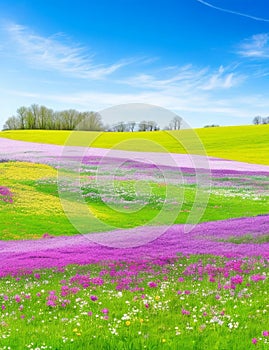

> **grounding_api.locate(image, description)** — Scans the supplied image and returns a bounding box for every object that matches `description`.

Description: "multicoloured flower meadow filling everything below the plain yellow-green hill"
[0,138,269,350]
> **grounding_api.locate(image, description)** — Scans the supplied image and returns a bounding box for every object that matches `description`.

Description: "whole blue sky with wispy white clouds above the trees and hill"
[0,0,269,127]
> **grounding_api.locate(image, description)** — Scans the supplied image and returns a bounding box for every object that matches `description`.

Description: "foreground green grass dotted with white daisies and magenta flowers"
[0,256,269,350]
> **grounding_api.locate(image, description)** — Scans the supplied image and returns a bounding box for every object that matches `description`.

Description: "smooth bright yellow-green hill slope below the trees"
[0,125,269,165]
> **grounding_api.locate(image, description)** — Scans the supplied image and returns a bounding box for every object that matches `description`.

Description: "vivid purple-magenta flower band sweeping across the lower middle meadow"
[0,215,269,276]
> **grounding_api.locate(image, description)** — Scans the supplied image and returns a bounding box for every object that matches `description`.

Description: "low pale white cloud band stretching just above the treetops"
[5,85,264,122]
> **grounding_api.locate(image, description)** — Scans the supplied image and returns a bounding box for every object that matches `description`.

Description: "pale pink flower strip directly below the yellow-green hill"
[0,138,269,175]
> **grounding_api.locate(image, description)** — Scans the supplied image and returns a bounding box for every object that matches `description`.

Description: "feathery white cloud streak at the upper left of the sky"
[5,24,133,79]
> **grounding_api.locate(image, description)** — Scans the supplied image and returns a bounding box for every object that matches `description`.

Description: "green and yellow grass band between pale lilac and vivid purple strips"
[0,162,268,240]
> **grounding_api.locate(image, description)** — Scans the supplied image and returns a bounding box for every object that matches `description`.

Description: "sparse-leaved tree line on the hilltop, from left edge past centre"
[3,104,182,132]
